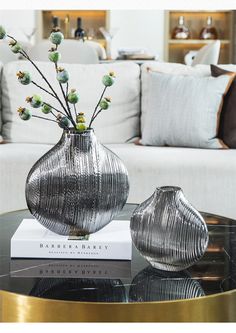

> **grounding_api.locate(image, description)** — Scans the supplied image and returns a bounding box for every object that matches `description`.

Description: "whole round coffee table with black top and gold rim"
[0,204,236,322]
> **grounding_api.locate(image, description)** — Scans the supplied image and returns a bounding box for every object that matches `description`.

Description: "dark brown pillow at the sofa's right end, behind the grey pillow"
[211,65,236,148]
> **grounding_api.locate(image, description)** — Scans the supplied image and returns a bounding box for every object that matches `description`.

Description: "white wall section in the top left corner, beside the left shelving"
[0,10,36,42]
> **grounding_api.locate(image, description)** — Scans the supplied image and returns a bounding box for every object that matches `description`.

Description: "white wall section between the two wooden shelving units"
[110,10,165,60]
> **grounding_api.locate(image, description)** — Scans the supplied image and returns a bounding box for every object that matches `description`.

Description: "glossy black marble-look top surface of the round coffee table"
[0,204,236,303]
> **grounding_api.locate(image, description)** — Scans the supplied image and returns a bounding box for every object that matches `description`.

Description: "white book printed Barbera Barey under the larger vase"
[11,219,132,260]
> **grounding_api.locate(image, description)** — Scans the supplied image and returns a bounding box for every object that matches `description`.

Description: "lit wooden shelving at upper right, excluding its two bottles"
[165,10,234,64]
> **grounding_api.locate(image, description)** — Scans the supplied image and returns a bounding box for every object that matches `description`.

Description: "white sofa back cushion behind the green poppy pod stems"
[2,61,140,144]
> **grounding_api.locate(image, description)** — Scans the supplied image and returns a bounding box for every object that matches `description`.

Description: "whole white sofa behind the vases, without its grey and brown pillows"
[0,61,236,218]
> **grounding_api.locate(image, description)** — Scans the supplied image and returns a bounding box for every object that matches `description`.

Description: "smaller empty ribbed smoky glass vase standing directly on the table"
[130,186,208,271]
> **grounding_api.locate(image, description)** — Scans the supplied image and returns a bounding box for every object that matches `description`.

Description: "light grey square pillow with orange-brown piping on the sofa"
[141,71,235,148]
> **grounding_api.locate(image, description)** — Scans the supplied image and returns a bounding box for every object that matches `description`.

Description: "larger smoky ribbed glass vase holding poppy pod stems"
[26,130,129,235]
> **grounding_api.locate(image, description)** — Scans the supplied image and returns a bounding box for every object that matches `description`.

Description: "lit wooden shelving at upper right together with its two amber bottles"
[165,10,235,64]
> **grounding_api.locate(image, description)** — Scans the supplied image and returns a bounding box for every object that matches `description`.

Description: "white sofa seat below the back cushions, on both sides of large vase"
[0,144,236,218]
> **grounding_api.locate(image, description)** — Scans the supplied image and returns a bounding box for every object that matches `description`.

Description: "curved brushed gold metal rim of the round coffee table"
[0,290,236,322]
